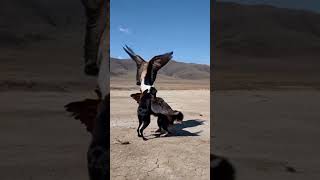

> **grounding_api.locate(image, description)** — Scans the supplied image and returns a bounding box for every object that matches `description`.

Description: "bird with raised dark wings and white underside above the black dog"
[123,46,173,92]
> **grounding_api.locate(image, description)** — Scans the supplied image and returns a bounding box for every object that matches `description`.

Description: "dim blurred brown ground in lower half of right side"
[211,89,320,180]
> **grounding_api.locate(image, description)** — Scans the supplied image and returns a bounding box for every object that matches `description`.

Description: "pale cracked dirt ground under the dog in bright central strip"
[110,89,210,180]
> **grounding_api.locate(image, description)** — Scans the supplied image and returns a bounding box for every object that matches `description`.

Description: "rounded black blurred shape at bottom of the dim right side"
[210,154,235,180]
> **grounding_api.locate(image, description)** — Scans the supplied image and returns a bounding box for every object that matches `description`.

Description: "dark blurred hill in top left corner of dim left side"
[0,0,85,47]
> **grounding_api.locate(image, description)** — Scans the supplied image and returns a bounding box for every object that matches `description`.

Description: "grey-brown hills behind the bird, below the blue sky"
[110,58,210,80]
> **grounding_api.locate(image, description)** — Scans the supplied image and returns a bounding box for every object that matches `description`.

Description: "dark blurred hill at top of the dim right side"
[212,2,320,57]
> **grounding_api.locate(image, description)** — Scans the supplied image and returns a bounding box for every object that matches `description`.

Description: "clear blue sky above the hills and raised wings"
[110,0,210,64]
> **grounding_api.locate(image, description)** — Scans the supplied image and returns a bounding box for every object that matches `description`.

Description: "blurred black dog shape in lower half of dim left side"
[65,91,110,180]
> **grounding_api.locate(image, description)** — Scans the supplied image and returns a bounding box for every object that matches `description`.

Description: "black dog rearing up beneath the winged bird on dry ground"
[131,87,183,140]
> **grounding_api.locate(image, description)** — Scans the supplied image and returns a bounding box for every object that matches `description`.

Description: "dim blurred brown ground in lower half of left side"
[0,91,90,180]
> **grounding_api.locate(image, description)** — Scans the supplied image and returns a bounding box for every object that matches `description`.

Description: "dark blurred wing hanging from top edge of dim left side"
[81,0,107,76]
